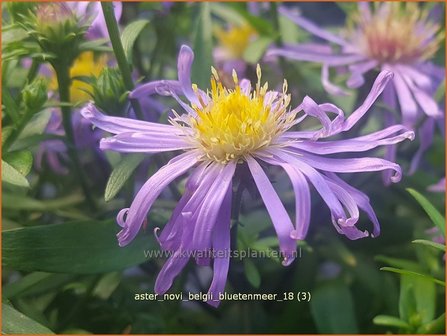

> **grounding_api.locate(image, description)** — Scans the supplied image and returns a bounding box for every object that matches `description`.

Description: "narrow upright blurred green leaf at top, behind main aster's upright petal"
[191,2,213,90]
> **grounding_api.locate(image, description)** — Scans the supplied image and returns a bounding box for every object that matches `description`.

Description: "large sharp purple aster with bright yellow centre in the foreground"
[82,46,414,305]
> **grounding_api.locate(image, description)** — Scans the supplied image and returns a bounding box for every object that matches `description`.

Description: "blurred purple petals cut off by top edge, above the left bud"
[67,1,123,40]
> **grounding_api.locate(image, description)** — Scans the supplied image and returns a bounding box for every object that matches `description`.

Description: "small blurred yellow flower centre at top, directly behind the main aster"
[216,25,256,59]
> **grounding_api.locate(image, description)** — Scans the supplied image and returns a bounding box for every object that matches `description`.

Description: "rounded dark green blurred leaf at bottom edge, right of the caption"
[310,281,358,334]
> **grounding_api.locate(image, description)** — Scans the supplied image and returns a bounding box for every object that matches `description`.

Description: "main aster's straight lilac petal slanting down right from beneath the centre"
[247,157,296,266]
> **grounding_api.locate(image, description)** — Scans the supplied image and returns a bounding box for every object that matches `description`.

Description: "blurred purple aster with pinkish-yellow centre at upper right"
[269,2,445,181]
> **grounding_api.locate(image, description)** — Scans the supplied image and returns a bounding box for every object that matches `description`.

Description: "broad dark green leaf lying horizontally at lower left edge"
[2,219,155,274]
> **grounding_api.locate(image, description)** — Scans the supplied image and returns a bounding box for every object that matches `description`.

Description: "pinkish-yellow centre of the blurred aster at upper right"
[353,2,443,63]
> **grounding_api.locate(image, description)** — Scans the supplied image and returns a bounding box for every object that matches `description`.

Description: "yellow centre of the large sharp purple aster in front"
[174,65,296,163]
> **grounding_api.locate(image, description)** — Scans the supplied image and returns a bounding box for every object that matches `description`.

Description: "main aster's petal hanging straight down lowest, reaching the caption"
[207,185,232,307]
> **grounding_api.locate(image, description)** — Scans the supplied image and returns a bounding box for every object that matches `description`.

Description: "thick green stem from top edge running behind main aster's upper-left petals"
[101,2,144,120]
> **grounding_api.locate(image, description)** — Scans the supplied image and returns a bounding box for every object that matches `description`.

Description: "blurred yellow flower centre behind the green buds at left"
[50,51,107,104]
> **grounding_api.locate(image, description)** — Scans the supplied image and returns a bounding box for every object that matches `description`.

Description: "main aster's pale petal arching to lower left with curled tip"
[117,152,198,246]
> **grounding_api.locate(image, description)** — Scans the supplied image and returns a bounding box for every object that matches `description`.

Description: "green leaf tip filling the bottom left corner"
[2,303,53,335]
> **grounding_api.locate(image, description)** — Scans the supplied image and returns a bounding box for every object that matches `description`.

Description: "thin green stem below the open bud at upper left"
[54,62,96,210]
